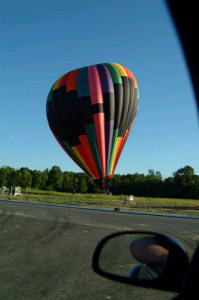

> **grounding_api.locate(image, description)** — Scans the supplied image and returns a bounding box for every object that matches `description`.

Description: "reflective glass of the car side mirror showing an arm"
[99,233,168,279]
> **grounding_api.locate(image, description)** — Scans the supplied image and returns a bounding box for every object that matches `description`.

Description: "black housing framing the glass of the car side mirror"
[92,231,189,292]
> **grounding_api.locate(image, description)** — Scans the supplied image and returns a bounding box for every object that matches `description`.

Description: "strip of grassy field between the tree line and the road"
[2,189,199,215]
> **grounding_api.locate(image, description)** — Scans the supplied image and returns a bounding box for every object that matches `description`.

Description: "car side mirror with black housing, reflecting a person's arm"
[93,231,189,292]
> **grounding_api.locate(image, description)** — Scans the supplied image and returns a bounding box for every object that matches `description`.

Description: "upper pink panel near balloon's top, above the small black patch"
[88,66,103,105]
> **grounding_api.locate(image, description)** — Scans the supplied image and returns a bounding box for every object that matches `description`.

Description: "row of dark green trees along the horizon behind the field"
[0,166,199,199]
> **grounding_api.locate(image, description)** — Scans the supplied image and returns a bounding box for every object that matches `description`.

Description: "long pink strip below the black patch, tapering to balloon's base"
[93,113,106,177]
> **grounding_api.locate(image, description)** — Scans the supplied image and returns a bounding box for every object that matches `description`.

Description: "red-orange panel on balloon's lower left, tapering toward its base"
[79,135,100,179]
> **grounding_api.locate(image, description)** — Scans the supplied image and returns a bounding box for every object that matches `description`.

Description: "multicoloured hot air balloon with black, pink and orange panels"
[46,63,139,189]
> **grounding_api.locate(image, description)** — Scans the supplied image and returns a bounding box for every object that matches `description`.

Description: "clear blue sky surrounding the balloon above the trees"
[0,0,199,177]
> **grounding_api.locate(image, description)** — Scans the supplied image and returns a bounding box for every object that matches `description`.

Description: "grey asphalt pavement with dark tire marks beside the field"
[0,201,199,300]
